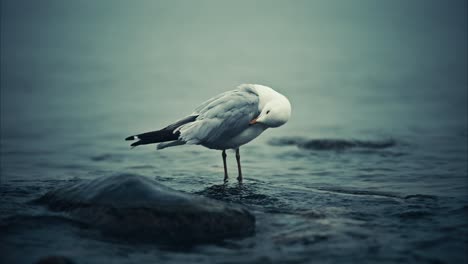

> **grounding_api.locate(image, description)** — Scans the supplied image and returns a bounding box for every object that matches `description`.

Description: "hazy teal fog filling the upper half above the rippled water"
[1,1,467,142]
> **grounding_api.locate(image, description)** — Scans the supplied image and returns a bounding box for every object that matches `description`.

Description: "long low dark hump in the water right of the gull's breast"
[269,137,396,150]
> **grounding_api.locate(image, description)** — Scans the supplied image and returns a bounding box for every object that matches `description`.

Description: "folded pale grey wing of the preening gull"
[176,87,259,145]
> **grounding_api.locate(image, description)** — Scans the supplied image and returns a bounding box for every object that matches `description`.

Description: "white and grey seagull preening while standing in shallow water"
[125,84,291,183]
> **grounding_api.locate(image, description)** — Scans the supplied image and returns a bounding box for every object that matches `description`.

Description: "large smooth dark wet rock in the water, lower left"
[37,174,255,244]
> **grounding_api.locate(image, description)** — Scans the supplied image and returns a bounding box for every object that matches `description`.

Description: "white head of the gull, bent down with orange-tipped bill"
[250,95,291,127]
